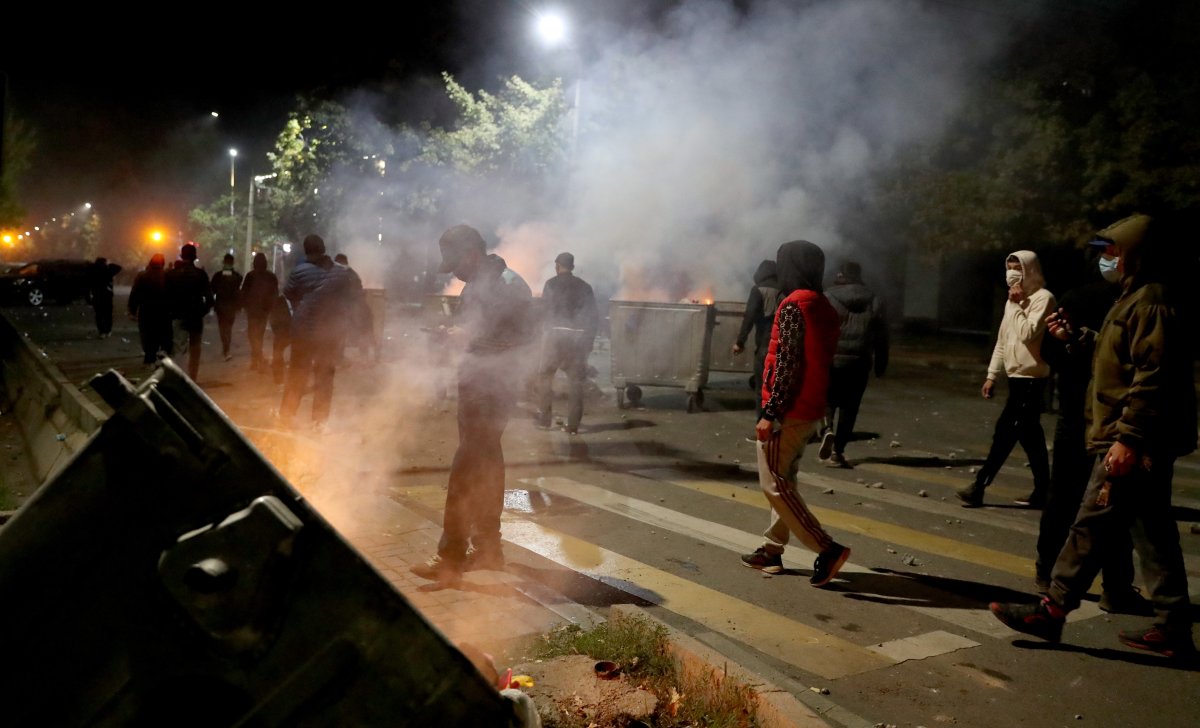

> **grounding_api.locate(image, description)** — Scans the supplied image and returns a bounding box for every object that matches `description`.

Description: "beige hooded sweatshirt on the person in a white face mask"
[988,251,1057,379]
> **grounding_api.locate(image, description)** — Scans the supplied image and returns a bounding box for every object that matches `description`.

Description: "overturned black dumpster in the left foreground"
[0,360,512,728]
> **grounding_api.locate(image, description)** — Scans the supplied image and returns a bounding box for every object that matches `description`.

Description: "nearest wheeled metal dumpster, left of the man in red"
[608,301,715,413]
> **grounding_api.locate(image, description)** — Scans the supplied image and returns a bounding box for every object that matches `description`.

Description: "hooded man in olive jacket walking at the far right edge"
[990,212,1196,661]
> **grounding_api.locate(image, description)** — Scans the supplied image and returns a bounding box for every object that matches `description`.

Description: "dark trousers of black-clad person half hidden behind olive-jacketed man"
[1036,407,1134,592]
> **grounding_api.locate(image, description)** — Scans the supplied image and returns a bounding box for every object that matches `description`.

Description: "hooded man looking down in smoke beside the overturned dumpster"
[412,225,533,580]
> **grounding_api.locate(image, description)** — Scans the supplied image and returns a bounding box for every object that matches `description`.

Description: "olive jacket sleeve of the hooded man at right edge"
[1116,306,1171,452]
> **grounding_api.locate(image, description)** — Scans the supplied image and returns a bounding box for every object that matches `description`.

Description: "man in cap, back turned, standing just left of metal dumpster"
[536,253,600,435]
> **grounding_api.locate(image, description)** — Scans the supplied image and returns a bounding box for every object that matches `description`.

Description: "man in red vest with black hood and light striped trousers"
[742,240,850,586]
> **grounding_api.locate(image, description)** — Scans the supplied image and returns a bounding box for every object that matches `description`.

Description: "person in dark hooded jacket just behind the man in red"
[817,260,888,468]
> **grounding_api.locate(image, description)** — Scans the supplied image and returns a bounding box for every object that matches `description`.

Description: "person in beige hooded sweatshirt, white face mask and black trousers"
[956,251,1056,509]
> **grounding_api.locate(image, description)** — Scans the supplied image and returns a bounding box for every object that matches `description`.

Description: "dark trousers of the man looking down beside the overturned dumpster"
[438,362,516,561]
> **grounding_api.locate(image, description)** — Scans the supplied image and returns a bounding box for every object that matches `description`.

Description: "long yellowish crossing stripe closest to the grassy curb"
[500,521,895,680]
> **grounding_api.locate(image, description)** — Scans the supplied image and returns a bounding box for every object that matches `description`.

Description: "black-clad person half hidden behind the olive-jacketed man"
[1034,239,1150,614]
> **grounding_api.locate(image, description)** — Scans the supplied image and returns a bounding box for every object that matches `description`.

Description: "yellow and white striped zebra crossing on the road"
[402,450,1196,680]
